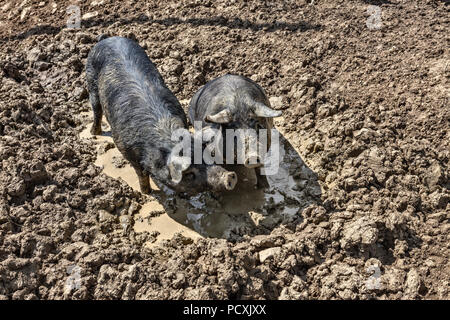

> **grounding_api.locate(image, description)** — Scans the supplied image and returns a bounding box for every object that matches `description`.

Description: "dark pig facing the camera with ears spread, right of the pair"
[189,74,281,188]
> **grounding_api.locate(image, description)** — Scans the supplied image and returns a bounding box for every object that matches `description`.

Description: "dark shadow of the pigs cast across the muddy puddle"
[153,129,322,240]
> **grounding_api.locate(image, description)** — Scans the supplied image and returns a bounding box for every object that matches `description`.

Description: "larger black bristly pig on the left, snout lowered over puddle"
[86,37,237,194]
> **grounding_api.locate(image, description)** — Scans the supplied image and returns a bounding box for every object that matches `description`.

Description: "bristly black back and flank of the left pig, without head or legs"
[90,37,187,146]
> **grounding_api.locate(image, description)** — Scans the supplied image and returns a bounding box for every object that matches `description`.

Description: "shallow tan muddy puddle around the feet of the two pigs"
[80,112,320,246]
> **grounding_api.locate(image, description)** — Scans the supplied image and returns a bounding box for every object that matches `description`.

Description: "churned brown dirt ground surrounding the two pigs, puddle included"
[0,0,450,299]
